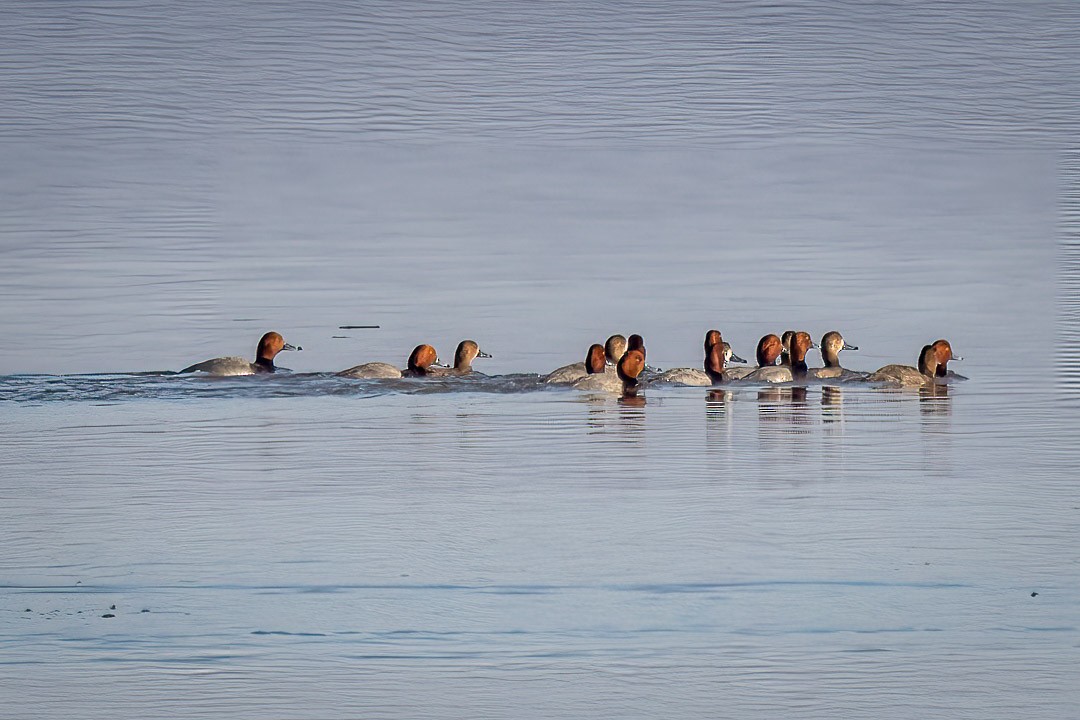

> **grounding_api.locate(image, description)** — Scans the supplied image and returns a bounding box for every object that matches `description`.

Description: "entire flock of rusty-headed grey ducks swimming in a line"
[180,330,964,395]
